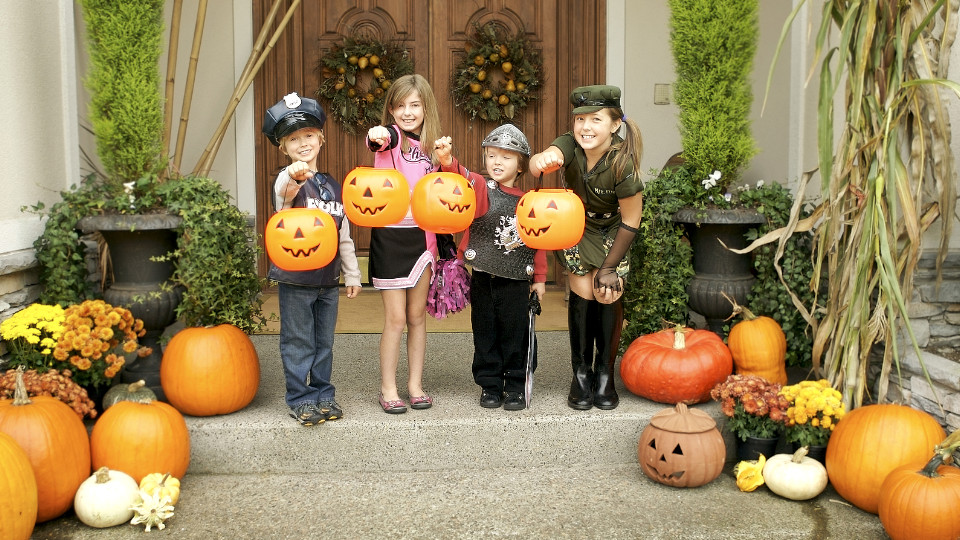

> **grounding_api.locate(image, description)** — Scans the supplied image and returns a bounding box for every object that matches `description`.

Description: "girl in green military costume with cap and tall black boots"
[530,85,643,410]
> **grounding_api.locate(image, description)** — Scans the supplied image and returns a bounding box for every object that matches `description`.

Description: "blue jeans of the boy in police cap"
[278,283,340,408]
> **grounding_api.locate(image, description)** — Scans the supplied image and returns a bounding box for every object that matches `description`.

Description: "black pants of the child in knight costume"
[470,269,537,392]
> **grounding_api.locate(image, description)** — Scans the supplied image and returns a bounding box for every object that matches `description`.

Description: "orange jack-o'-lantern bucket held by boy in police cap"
[264,208,340,271]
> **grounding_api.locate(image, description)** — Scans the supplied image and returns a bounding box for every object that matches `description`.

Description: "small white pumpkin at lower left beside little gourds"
[73,467,140,528]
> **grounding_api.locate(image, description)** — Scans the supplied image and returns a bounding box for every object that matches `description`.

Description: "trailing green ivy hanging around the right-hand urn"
[621,171,813,367]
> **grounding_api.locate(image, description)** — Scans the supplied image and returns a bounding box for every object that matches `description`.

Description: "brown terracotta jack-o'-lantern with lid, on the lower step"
[637,403,727,487]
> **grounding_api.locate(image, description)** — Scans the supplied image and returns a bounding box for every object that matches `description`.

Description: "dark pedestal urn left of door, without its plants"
[78,214,183,400]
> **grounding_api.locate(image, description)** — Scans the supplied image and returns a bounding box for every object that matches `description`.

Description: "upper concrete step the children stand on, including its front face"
[187,332,704,474]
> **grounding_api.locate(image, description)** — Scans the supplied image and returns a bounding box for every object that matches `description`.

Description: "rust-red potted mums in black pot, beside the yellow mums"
[710,375,789,460]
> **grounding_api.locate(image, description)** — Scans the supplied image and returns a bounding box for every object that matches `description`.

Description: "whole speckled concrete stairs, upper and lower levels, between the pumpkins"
[32,332,885,540]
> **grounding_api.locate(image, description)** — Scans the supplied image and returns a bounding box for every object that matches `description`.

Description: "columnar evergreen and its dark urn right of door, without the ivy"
[670,0,764,334]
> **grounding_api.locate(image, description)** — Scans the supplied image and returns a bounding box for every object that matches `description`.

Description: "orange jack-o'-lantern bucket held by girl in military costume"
[517,189,586,249]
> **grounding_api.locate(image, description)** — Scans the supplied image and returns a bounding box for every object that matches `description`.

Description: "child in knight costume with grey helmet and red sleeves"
[436,124,547,411]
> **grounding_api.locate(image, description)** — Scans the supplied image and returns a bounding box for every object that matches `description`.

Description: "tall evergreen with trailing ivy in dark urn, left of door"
[25,0,266,398]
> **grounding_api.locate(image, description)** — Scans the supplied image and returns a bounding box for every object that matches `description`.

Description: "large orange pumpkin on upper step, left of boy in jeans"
[160,324,260,416]
